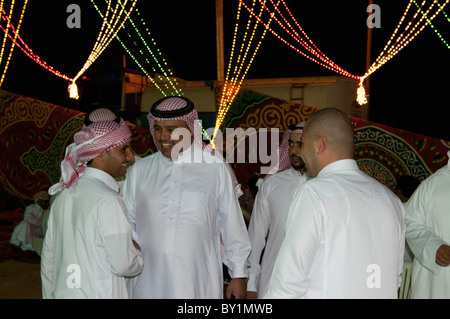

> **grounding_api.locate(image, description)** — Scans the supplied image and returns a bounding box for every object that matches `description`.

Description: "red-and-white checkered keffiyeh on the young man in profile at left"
[48,108,132,195]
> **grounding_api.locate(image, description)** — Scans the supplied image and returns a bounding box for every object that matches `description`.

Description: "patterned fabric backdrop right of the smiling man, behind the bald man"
[224,90,450,195]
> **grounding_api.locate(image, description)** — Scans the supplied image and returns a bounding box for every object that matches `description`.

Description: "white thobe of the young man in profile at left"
[41,167,143,299]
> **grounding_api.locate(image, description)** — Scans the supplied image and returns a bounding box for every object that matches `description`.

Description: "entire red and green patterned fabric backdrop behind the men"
[0,90,450,208]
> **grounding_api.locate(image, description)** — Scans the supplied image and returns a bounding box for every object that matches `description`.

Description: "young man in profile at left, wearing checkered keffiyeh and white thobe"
[41,108,143,299]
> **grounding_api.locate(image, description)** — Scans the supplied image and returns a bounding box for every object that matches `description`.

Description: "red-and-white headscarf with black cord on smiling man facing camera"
[147,96,243,197]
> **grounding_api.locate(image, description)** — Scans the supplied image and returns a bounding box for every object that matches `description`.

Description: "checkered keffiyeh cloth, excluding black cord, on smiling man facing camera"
[147,96,243,197]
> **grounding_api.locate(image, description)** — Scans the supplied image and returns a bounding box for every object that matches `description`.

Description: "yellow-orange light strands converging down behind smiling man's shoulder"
[211,0,279,145]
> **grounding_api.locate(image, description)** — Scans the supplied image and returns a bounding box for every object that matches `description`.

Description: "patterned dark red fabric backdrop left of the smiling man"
[0,90,155,201]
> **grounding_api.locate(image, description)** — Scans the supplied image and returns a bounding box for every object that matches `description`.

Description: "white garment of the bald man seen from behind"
[264,159,405,298]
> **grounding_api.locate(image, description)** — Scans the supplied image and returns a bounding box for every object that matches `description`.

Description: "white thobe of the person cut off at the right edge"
[406,156,450,299]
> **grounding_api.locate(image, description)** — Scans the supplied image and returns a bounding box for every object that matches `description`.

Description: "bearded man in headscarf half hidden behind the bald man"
[247,122,307,299]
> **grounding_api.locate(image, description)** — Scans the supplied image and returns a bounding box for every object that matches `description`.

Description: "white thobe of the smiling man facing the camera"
[123,147,250,299]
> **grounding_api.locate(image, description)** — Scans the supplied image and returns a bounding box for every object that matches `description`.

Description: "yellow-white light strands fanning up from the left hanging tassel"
[69,0,137,99]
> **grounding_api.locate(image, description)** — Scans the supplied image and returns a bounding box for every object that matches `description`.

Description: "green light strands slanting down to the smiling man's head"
[91,0,183,96]
